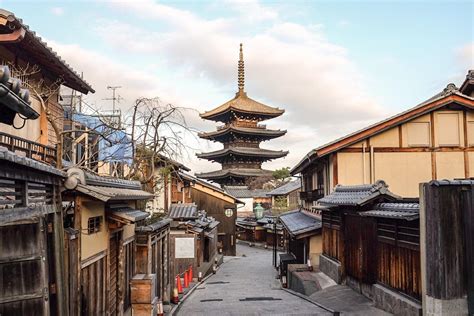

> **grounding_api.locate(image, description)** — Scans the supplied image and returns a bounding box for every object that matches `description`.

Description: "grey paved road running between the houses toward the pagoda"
[178,245,330,316]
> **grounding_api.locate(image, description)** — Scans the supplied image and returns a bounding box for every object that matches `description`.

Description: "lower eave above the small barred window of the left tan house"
[75,184,153,202]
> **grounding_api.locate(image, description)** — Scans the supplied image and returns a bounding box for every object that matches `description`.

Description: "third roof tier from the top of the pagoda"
[197,147,288,160]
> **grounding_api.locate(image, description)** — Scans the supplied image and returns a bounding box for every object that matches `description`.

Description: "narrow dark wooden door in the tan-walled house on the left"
[108,233,120,315]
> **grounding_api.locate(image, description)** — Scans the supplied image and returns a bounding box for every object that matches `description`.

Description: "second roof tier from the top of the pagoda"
[198,125,286,141]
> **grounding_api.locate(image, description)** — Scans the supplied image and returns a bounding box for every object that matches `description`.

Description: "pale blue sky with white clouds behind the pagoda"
[0,0,474,172]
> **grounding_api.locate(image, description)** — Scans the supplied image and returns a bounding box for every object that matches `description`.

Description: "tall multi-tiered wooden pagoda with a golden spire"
[196,44,288,186]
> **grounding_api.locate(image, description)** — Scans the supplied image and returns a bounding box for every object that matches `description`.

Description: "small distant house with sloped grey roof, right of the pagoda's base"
[267,179,301,215]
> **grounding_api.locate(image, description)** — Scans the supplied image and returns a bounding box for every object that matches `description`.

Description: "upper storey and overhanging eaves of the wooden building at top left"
[0,9,94,152]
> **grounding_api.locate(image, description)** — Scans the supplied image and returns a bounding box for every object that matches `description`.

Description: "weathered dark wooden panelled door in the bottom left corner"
[0,206,50,315]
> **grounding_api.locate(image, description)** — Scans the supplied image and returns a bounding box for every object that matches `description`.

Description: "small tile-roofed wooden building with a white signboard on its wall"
[168,203,219,277]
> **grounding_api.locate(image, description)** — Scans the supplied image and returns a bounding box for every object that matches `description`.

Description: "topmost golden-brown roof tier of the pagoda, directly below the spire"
[200,91,285,123]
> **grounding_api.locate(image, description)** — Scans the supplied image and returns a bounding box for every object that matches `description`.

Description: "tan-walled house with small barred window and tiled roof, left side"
[63,168,152,315]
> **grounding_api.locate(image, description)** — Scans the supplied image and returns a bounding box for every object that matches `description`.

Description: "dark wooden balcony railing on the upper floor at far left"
[0,132,56,166]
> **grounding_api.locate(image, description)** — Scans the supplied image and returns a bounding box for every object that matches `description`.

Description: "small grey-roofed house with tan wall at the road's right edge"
[279,210,322,267]
